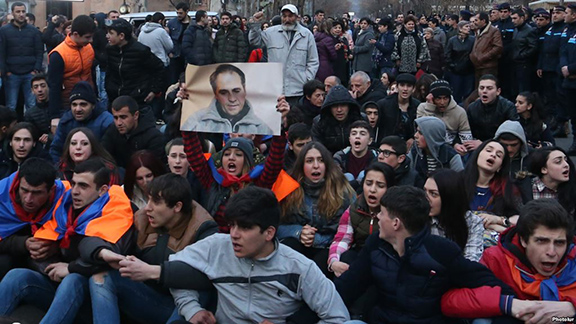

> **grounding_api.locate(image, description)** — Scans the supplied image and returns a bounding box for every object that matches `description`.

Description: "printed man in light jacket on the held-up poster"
[181,64,273,134]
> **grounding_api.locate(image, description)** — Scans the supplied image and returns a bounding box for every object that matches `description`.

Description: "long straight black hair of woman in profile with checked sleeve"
[430,169,469,249]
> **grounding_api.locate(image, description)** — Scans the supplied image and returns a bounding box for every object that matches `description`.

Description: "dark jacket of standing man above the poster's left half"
[182,23,214,65]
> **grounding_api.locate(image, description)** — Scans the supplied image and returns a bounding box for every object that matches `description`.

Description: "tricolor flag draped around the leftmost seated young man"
[0,172,68,240]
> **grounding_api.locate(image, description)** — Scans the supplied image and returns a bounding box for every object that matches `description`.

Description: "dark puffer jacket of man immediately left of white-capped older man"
[213,23,248,63]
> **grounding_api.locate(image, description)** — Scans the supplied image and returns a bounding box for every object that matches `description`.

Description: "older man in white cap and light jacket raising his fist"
[248,4,320,105]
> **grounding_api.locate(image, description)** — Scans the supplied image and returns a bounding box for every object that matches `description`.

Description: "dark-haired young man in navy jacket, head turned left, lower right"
[336,186,513,323]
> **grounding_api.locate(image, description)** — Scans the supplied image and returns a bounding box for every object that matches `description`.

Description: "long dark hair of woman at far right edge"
[528,146,576,215]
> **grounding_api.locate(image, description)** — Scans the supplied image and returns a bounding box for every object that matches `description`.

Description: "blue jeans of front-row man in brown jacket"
[89,270,178,324]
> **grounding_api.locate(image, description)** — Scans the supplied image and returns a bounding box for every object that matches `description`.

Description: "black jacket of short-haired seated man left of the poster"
[102,110,166,168]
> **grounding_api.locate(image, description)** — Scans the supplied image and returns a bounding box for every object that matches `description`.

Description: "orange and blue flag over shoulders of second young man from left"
[34,185,133,248]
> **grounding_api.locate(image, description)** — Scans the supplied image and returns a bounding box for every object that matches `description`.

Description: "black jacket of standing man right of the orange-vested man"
[106,38,164,107]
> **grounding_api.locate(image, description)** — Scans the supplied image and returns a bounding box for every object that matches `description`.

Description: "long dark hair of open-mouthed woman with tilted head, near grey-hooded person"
[464,139,518,216]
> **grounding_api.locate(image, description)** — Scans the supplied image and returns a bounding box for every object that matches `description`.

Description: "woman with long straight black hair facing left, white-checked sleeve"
[424,170,484,261]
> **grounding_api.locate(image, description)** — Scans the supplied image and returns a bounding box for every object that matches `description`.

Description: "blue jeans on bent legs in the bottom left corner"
[0,269,88,324]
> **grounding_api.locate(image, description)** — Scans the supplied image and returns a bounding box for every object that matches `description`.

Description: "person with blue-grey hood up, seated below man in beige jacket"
[408,117,464,188]
